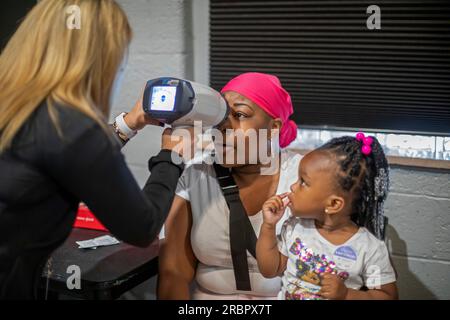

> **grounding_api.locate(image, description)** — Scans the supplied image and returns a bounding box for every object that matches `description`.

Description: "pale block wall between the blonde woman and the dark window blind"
[110,0,192,186]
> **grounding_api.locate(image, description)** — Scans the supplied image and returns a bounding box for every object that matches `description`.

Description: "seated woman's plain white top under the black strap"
[176,150,301,297]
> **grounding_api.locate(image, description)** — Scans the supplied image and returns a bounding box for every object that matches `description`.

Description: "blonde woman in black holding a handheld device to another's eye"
[0,0,190,299]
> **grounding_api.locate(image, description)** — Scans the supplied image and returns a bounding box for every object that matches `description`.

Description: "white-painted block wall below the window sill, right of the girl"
[385,166,450,299]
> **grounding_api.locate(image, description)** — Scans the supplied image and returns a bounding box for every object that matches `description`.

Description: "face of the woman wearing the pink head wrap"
[216,91,281,168]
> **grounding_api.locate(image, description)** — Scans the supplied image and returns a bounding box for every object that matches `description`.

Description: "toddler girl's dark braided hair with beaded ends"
[318,136,389,239]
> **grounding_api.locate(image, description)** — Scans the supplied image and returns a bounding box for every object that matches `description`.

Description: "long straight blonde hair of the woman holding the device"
[0,0,132,153]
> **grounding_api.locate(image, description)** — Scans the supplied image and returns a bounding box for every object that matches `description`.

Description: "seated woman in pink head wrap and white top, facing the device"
[158,73,301,299]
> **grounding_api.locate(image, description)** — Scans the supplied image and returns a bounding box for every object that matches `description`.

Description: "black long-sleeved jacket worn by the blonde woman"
[0,103,183,299]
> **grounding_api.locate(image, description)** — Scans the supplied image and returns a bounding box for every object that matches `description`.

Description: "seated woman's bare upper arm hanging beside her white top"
[158,196,197,300]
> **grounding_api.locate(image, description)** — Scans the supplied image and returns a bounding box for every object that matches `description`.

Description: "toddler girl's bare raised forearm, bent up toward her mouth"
[256,223,287,278]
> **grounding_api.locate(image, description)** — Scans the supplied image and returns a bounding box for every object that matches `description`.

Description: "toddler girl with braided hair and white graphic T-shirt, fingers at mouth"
[256,133,397,300]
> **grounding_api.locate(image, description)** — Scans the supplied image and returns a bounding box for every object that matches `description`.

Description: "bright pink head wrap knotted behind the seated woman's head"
[221,72,297,148]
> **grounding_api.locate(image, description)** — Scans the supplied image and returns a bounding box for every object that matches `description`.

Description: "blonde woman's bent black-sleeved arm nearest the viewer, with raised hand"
[37,108,190,246]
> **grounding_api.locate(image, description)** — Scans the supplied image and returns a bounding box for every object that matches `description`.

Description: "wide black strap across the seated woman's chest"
[214,163,257,291]
